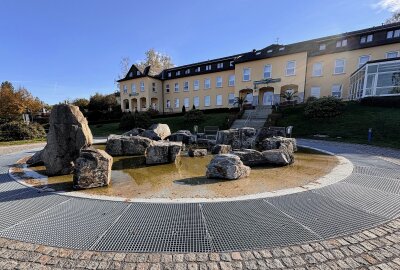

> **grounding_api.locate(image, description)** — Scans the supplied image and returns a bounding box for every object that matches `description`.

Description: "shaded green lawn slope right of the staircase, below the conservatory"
[278,103,400,148]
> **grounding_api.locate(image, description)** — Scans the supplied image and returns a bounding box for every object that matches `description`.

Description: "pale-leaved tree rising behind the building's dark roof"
[136,49,174,74]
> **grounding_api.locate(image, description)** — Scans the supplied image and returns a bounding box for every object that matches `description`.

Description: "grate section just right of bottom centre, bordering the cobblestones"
[203,200,318,251]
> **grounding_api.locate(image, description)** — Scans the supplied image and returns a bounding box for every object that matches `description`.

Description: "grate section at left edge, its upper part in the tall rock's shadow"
[0,189,68,231]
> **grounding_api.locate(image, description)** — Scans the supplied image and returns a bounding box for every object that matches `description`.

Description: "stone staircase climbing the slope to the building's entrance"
[231,105,272,129]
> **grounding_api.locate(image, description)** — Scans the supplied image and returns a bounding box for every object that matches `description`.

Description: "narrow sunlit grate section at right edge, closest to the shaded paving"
[344,173,400,195]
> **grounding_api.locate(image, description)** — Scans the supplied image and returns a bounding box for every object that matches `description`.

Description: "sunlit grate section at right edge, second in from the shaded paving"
[313,183,400,219]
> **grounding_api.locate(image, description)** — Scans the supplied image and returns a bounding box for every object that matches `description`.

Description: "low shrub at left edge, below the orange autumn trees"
[0,121,46,141]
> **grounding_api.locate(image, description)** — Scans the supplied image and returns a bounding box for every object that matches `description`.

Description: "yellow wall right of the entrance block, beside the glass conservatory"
[305,44,400,99]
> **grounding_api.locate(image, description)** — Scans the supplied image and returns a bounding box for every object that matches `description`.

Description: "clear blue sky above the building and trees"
[0,0,400,104]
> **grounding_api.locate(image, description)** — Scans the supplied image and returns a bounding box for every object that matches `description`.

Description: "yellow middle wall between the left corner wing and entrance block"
[163,70,235,112]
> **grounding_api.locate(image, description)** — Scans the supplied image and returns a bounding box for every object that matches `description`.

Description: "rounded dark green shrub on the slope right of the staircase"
[304,97,344,118]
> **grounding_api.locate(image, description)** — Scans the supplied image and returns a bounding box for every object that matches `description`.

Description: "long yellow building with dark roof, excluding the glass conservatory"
[119,23,400,113]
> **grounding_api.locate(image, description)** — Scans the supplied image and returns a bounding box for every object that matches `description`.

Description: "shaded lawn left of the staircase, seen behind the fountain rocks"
[90,113,229,137]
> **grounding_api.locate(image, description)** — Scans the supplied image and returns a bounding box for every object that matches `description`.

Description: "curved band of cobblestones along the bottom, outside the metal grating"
[0,219,400,270]
